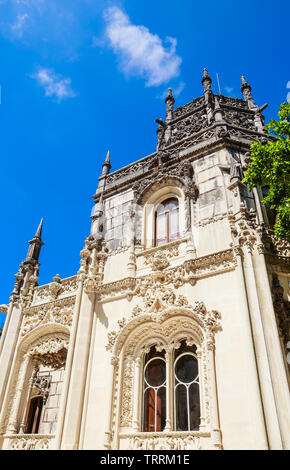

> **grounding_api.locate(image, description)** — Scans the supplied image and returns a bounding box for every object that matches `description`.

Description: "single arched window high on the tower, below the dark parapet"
[155,198,179,246]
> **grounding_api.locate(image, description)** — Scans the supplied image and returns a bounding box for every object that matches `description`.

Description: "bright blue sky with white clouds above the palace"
[0,0,290,321]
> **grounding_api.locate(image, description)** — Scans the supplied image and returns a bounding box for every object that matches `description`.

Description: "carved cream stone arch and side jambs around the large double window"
[107,299,220,450]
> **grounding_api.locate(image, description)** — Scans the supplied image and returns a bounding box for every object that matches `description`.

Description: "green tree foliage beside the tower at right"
[244,103,290,239]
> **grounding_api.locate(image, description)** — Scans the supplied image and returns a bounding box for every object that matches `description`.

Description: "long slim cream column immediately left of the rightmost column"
[244,247,282,449]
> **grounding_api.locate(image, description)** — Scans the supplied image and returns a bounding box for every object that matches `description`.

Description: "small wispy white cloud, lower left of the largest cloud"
[32,68,77,101]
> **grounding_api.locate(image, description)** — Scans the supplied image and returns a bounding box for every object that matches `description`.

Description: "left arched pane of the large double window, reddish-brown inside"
[143,346,166,432]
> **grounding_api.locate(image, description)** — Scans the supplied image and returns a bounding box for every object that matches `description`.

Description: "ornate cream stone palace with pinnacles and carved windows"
[0,69,290,450]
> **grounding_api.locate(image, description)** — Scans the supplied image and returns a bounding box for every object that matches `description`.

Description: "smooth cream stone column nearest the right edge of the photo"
[253,251,290,449]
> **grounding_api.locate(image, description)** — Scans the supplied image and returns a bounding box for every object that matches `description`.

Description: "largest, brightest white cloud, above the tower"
[104,6,181,86]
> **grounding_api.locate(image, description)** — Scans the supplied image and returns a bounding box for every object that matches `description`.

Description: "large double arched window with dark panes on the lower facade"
[142,340,200,432]
